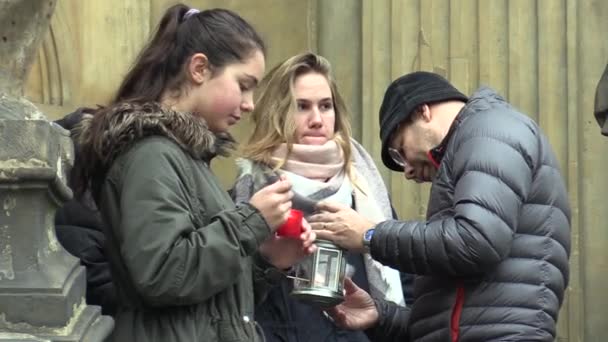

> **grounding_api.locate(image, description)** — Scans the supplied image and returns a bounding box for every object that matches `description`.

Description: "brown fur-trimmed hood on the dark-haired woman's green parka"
[76,102,235,170]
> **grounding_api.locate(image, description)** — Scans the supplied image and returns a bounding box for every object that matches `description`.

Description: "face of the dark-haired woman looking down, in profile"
[189,51,265,133]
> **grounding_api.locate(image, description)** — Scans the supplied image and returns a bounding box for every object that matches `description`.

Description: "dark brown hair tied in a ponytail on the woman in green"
[112,4,266,103]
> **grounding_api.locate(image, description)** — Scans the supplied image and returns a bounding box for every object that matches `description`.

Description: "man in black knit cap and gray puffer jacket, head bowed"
[309,72,570,342]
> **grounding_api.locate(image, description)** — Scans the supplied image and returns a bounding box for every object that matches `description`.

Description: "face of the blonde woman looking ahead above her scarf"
[293,72,336,145]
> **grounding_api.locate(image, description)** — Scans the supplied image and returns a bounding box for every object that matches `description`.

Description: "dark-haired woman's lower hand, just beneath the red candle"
[259,219,317,270]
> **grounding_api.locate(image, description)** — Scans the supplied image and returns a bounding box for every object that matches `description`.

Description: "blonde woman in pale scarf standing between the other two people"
[232,53,403,342]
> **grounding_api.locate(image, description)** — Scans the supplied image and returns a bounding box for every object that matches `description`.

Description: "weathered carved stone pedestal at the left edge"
[0,0,113,341]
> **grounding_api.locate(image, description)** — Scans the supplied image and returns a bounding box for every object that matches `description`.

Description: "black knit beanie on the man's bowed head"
[380,71,468,171]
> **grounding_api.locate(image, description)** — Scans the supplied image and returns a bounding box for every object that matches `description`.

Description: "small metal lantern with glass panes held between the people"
[290,240,346,307]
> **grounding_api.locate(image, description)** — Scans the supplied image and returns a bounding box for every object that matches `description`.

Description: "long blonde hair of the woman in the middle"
[241,53,352,176]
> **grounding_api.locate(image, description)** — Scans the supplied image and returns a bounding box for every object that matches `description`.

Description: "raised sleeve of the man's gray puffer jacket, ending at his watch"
[371,114,536,277]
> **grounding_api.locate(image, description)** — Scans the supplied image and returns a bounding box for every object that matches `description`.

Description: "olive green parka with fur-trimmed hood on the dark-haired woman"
[80,103,278,342]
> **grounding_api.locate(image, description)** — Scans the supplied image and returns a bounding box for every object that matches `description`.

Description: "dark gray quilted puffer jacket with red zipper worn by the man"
[371,88,570,342]
